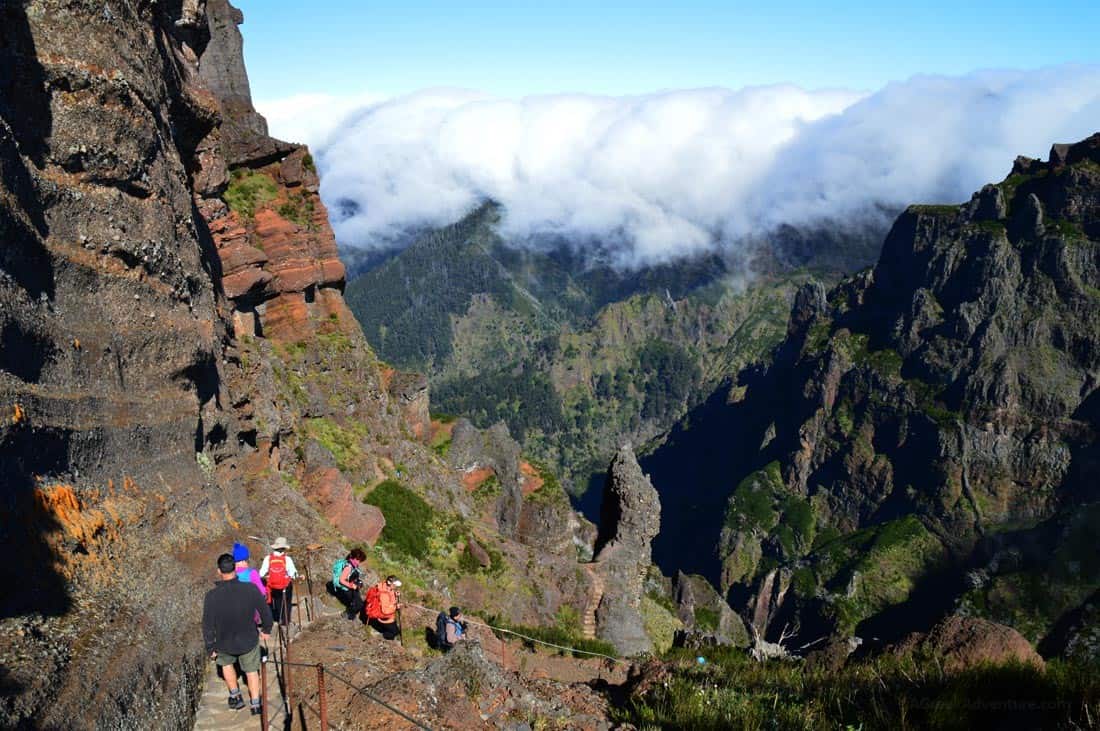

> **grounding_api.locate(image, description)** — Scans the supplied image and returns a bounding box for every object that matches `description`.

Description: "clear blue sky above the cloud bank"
[237,0,1100,100]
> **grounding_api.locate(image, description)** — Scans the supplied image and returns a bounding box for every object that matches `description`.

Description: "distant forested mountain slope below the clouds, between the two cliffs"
[348,203,866,492]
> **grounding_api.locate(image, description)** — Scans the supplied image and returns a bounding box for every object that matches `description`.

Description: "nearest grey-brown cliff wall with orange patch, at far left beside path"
[0,1,264,728]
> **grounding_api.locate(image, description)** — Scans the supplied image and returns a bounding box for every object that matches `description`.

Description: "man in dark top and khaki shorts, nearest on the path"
[202,553,273,716]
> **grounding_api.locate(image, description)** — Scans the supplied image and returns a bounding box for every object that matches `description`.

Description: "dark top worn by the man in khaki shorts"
[202,577,273,655]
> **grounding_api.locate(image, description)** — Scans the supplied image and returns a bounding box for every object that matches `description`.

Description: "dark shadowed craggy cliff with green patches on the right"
[642,136,1100,655]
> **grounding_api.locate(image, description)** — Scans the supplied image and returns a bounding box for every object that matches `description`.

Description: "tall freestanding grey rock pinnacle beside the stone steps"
[594,445,661,655]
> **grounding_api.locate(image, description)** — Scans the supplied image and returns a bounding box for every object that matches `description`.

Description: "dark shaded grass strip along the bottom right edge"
[613,647,1100,731]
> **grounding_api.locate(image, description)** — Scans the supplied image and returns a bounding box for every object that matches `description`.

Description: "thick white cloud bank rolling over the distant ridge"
[301,66,1100,264]
